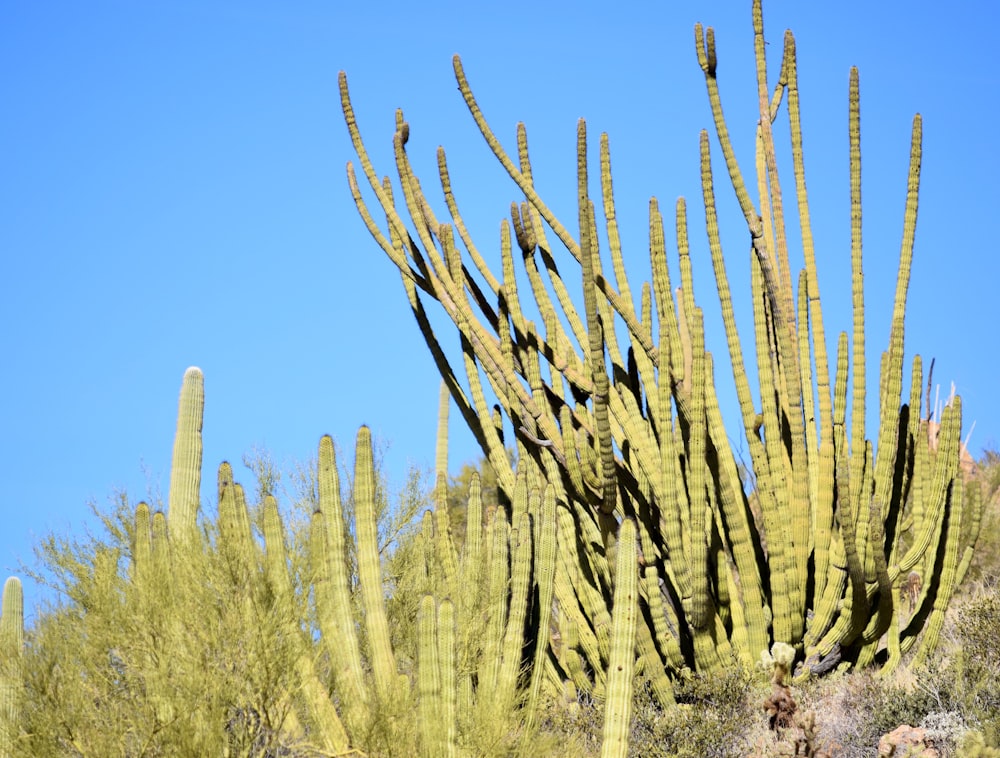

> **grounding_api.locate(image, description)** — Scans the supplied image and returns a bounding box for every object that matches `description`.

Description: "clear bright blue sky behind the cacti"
[0,0,1000,624]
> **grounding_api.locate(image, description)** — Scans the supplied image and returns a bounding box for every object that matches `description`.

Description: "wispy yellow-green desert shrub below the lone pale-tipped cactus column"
[18,498,304,756]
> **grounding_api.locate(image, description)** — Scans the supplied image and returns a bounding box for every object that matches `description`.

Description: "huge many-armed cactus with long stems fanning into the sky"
[340,0,981,705]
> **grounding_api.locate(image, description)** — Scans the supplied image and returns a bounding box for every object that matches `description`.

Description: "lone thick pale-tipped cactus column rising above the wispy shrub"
[167,366,205,543]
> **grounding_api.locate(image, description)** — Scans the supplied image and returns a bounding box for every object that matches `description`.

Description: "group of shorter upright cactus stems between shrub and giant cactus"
[306,396,562,755]
